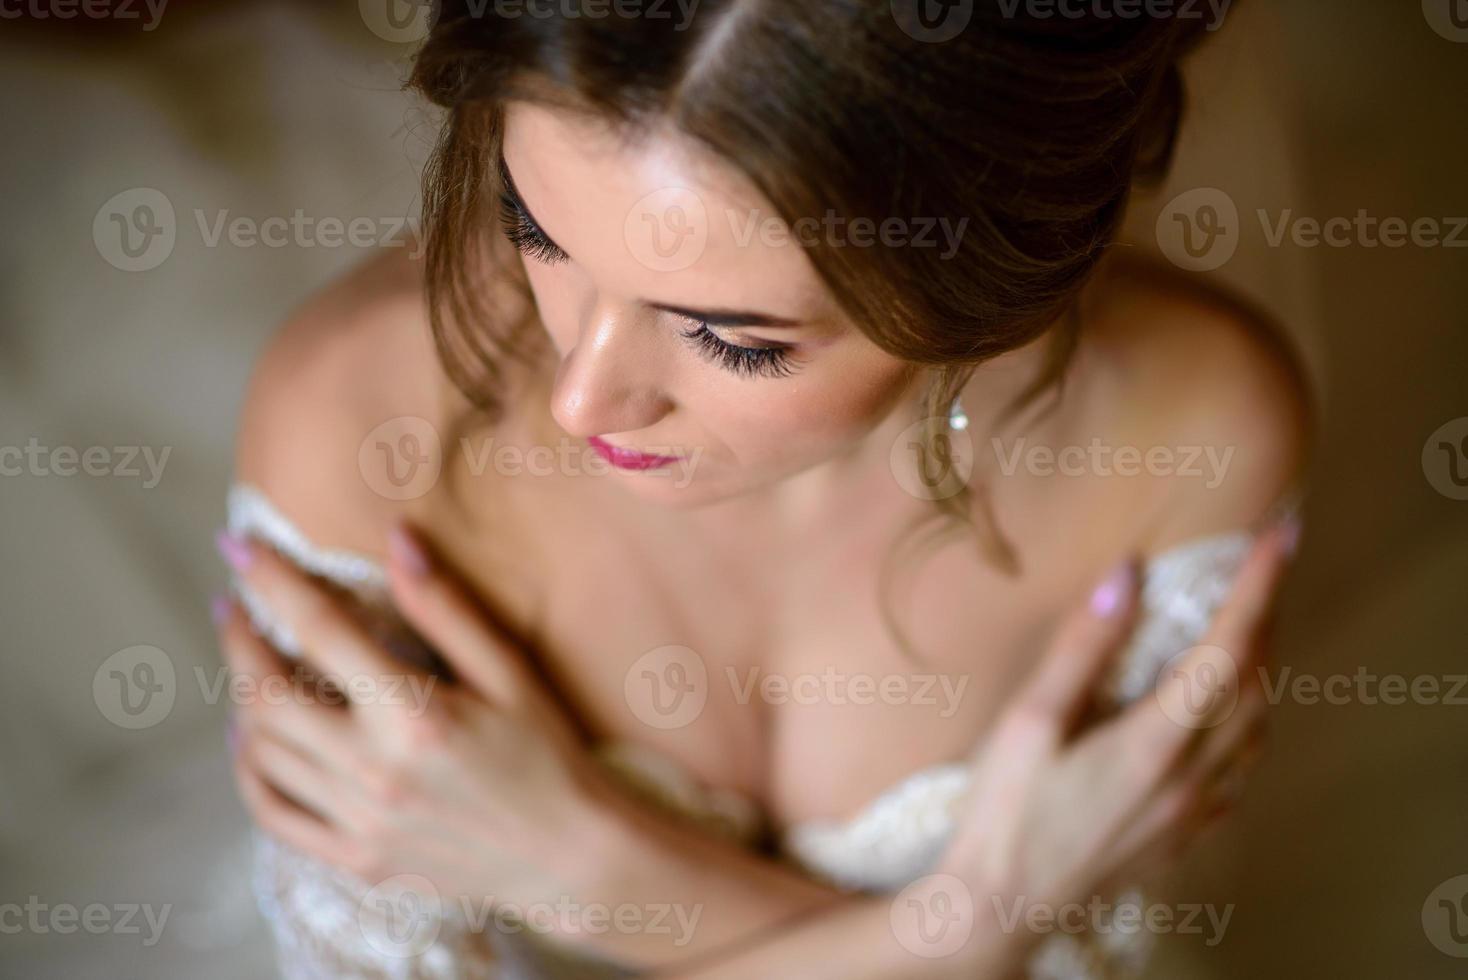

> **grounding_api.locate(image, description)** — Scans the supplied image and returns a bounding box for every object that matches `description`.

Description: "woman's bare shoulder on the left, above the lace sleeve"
[235,249,440,553]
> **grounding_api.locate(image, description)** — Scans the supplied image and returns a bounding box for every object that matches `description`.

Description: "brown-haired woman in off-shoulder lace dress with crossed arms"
[217,0,1308,977]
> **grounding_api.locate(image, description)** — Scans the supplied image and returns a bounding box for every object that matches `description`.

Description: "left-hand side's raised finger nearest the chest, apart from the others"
[388,524,539,704]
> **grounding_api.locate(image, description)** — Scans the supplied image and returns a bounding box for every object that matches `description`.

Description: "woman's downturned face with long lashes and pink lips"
[504,103,915,506]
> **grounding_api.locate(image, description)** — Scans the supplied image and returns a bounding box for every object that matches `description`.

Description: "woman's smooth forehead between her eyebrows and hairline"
[505,101,828,318]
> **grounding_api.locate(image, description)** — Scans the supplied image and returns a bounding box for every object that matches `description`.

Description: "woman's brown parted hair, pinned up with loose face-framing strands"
[410,0,1204,657]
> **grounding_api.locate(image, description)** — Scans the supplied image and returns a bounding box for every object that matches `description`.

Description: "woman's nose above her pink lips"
[551,304,672,439]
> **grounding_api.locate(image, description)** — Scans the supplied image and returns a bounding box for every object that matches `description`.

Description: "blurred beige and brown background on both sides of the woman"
[0,0,1468,980]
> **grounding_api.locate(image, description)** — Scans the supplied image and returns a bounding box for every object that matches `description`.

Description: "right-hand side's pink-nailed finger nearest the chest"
[1016,560,1138,736]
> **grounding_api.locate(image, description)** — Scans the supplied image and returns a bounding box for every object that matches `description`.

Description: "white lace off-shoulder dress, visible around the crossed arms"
[228,486,1280,980]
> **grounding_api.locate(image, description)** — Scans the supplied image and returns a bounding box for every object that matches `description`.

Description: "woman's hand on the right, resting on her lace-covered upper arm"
[941,524,1298,911]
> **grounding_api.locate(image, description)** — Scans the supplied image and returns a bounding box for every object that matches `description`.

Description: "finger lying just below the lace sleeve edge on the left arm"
[220,535,427,706]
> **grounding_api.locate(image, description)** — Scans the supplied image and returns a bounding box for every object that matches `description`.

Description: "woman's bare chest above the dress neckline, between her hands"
[452,492,1086,826]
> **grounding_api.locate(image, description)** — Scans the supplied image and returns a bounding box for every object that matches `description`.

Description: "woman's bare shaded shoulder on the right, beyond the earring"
[1088,249,1315,549]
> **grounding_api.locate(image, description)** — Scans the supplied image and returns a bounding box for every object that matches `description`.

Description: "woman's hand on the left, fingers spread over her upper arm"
[220,528,613,904]
